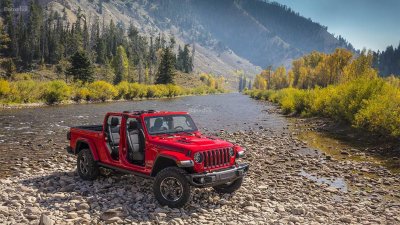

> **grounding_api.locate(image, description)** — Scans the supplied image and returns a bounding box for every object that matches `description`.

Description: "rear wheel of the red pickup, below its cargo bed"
[77,149,100,180]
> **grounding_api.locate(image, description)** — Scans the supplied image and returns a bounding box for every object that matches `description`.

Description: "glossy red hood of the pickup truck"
[149,135,233,151]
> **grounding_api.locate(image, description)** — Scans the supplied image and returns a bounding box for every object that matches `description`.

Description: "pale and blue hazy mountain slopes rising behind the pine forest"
[14,0,353,80]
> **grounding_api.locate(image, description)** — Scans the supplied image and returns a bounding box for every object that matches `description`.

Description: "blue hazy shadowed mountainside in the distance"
[143,0,353,67]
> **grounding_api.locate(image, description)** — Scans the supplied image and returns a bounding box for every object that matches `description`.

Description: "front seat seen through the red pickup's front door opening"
[127,120,144,162]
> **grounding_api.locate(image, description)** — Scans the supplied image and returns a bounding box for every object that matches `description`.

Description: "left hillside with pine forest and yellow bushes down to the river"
[0,0,225,104]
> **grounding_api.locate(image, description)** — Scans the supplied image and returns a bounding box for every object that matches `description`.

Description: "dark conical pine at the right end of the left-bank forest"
[156,47,175,84]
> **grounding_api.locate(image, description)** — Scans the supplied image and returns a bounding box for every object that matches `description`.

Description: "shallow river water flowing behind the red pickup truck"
[0,93,288,178]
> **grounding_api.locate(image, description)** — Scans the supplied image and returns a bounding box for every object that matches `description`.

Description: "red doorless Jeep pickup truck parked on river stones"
[67,110,249,207]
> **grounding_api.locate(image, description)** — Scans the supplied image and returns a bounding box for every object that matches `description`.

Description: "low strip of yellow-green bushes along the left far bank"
[0,79,225,105]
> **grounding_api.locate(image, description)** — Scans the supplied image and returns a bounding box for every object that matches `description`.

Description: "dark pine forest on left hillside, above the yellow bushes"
[2,0,197,84]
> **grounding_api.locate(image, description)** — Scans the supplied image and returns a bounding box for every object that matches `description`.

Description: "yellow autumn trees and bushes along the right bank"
[247,49,400,137]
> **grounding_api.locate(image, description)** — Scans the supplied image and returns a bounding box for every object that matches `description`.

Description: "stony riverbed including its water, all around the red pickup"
[0,94,400,225]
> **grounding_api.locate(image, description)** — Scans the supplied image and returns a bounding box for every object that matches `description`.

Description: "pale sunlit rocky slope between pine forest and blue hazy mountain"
[47,0,261,81]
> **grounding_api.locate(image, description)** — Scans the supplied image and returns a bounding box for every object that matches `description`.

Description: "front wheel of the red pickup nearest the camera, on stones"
[153,167,190,208]
